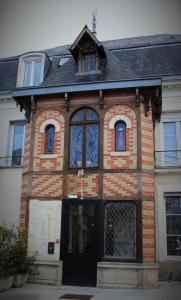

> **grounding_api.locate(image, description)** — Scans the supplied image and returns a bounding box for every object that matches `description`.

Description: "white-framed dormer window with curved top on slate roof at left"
[17,52,47,87]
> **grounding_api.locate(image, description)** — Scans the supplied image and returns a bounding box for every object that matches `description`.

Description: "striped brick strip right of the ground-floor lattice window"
[142,201,155,262]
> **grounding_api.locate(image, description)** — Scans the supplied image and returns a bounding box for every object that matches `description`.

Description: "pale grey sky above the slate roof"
[0,0,181,57]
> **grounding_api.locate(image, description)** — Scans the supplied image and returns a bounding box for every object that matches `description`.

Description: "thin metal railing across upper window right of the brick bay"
[155,150,181,168]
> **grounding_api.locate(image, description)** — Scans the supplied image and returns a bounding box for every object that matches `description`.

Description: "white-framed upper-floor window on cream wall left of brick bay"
[9,122,25,166]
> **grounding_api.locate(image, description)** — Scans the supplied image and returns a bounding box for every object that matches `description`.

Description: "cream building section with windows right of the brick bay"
[155,78,181,280]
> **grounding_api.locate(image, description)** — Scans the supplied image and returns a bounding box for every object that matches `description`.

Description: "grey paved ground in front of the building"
[0,282,181,300]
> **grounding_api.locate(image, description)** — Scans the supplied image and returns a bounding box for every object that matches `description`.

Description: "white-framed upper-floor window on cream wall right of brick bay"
[163,121,181,167]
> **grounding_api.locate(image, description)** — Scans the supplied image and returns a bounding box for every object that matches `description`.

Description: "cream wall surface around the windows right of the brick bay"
[155,80,181,272]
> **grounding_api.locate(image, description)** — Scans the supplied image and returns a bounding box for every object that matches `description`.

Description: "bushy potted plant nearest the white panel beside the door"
[11,230,37,287]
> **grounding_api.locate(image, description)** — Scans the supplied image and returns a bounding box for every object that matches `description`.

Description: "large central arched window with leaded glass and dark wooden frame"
[69,108,99,168]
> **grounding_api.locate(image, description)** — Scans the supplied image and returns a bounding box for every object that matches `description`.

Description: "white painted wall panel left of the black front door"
[28,199,62,262]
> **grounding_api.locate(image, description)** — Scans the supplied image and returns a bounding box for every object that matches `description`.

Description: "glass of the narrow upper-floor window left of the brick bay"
[12,124,24,166]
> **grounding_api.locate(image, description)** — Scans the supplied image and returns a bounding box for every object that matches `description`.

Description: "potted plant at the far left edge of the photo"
[0,225,16,291]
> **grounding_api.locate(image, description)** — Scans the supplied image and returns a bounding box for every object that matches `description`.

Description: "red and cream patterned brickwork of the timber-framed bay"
[20,95,155,262]
